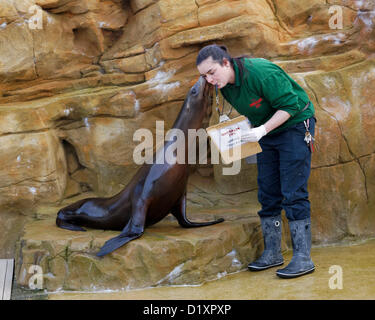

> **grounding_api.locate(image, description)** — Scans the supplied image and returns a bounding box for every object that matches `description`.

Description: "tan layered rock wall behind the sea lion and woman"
[0,0,375,254]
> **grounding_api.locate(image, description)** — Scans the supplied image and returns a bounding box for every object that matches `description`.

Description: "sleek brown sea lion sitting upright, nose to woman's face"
[56,77,224,257]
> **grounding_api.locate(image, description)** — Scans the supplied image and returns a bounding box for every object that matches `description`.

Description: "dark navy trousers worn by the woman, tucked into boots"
[257,118,315,221]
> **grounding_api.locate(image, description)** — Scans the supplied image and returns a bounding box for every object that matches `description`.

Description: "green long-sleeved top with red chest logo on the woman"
[220,58,314,134]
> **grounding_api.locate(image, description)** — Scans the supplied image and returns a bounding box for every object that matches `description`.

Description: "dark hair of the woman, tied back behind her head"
[196,44,249,80]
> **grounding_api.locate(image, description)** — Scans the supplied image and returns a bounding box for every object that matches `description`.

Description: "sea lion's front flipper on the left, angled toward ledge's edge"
[96,199,148,257]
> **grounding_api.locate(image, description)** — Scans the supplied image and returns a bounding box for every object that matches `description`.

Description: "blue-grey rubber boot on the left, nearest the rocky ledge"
[248,215,284,271]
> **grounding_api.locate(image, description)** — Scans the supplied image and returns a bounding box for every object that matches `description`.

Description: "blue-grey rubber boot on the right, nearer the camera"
[276,218,315,278]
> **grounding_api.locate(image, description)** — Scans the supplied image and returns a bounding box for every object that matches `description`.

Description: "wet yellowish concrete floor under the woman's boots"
[48,239,375,300]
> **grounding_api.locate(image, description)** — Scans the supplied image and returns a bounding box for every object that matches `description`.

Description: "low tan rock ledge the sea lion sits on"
[16,205,294,292]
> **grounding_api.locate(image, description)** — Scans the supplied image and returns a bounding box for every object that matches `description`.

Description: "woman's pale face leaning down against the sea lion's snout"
[197,57,235,89]
